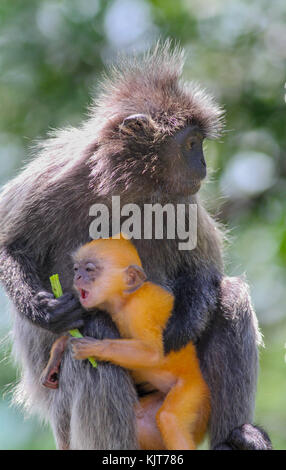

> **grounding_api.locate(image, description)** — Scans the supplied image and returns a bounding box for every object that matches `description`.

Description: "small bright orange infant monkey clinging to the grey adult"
[41,235,210,450]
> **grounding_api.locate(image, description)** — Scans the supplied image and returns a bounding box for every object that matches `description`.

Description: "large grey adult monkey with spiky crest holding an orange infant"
[0,44,271,449]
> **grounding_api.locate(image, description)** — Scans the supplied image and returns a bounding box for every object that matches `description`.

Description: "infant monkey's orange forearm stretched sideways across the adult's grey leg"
[71,338,162,369]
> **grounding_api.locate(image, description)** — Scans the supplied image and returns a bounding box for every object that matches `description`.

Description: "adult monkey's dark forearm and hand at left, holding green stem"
[0,243,84,333]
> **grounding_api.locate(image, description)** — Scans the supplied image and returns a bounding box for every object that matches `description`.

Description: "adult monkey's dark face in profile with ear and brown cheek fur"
[96,114,206,202]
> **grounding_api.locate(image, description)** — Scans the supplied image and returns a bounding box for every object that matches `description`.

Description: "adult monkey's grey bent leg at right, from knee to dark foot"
[197,277,271,450]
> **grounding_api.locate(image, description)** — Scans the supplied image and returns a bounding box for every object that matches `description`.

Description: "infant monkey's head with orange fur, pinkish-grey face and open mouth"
[73,237,146,312]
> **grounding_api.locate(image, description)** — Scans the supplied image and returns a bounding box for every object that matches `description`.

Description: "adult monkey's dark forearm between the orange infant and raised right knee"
[163,269,221,353]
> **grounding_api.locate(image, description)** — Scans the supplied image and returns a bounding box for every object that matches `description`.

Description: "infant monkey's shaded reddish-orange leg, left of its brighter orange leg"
[135,392,166,450]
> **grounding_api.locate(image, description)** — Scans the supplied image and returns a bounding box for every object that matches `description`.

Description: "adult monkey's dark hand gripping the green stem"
[32,291,86,333]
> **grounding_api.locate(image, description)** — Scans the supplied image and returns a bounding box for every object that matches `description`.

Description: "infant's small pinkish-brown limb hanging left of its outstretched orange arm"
[41,335,69,389]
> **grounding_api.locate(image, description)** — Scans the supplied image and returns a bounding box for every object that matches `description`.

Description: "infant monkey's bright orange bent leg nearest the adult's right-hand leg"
[156,380,209,450]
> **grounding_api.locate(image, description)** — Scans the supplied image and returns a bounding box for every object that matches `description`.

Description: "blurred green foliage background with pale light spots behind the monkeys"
[0,0,286,449]
